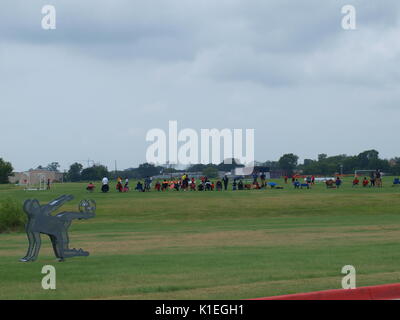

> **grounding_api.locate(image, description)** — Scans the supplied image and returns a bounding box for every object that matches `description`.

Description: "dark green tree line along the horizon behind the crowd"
[0,150,400,183]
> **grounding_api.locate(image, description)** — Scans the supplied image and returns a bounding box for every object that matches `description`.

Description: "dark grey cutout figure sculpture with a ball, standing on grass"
[20,195,96,262]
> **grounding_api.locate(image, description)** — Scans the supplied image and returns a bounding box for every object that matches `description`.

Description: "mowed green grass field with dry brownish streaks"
[0,178,400,299]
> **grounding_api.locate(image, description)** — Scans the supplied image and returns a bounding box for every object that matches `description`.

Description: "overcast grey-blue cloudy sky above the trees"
[0,0,400,171]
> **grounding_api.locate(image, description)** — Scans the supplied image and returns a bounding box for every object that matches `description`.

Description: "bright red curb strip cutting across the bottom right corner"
[252,284,400,300]
